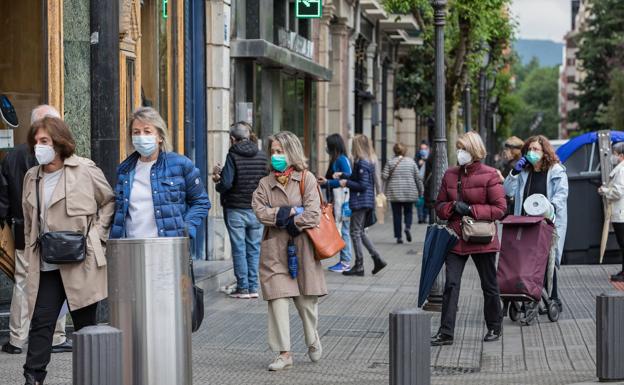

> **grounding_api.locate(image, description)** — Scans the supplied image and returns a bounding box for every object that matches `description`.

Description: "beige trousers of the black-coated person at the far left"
[9,250,67,348]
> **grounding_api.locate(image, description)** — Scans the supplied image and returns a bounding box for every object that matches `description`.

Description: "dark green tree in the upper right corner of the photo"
[570,0,624,131]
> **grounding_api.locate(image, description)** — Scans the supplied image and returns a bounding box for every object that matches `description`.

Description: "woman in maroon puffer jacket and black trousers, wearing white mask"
[431,131,506,346]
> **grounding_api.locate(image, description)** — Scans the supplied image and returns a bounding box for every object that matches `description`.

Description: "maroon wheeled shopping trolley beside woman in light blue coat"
[497,215,559,324]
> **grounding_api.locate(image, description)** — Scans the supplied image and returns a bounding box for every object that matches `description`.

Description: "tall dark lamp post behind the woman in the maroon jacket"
[424,0,448,311]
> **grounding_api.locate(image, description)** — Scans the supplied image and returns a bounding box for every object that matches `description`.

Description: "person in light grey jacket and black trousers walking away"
[381,143,425,243]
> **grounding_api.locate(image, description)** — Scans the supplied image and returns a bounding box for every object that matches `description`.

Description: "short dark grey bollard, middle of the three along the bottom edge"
[390,309,431,385]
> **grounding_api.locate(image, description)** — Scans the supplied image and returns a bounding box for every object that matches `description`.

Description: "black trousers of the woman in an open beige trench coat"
[24,270,97,382]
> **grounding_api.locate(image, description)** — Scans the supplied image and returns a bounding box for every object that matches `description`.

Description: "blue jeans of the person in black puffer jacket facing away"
[225,209,264,293]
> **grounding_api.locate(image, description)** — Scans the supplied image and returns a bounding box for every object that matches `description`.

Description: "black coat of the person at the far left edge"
[0,144,37,250]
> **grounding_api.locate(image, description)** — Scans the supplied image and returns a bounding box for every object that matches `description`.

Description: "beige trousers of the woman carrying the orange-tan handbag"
[269,295,318,352]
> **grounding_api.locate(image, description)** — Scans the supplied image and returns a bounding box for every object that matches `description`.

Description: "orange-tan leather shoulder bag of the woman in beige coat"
[299,171,345,261]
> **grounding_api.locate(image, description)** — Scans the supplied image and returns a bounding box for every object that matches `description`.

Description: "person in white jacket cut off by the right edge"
[598,142,624,282]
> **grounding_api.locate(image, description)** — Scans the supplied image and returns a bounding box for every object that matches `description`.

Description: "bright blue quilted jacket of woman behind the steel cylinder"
[110,152,210,238]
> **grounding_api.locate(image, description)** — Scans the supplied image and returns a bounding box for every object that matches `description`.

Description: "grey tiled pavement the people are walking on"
[0,220,617,385]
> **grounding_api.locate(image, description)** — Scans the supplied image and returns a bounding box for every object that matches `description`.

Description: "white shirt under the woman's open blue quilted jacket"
[126,159,158,238]
